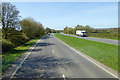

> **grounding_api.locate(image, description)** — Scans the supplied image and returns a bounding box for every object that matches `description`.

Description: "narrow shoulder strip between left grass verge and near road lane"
[2,35,46,80]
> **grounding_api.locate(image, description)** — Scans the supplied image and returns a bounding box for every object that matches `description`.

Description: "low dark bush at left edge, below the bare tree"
[2,39,13,53]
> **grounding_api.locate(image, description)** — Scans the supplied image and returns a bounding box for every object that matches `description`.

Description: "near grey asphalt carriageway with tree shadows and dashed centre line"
[3,35,118,80]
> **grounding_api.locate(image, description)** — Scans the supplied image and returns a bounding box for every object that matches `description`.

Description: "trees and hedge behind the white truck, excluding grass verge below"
[64,25,120,34]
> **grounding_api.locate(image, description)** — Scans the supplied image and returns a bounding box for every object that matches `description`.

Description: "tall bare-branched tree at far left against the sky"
[2,2,20,39]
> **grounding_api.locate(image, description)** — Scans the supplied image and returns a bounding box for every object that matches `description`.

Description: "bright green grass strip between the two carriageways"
[55,34,118,71]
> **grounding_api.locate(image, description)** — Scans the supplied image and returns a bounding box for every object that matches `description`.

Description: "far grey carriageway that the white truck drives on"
[61,33,120,45]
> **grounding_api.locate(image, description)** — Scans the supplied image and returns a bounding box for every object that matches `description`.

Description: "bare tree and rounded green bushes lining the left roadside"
[0,2,45,53]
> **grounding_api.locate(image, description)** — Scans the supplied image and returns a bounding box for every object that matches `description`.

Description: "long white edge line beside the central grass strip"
[55,34,118,78]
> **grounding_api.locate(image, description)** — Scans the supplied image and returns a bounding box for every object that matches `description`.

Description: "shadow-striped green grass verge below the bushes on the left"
[2,35,45,73]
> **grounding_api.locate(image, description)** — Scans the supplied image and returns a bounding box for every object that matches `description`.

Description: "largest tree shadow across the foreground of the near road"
[12,55,76,79]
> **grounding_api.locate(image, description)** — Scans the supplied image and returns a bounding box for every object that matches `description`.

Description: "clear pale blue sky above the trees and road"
[11,2,118,30]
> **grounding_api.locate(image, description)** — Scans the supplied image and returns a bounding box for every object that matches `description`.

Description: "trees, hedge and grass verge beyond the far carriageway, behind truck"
[64,25,120,40]
